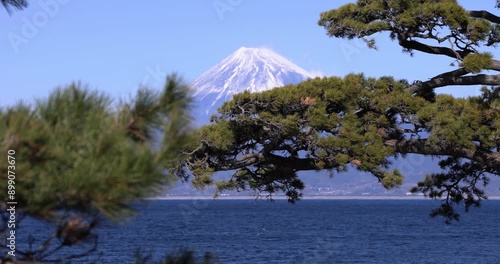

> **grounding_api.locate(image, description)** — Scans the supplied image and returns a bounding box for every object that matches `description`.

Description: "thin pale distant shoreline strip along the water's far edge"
[146,195,500,200]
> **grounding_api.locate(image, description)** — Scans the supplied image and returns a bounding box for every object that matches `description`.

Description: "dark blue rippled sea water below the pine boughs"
[8,200,500,264]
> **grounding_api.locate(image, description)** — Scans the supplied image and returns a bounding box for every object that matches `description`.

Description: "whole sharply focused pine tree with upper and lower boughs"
[184,0,500,222]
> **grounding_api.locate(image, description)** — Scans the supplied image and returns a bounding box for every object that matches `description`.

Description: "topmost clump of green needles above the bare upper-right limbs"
[319,0,491,52]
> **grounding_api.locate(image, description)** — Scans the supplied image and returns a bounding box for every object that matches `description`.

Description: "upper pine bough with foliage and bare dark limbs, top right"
[318,0,500,101]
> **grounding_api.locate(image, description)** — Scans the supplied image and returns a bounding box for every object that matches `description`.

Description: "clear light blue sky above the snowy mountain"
[0,0,499,106]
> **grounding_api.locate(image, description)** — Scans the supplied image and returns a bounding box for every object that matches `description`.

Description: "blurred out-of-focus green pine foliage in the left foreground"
[0,75,191,260]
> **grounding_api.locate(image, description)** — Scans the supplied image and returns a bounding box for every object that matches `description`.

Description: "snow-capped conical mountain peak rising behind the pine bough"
[191,47,318,121]
